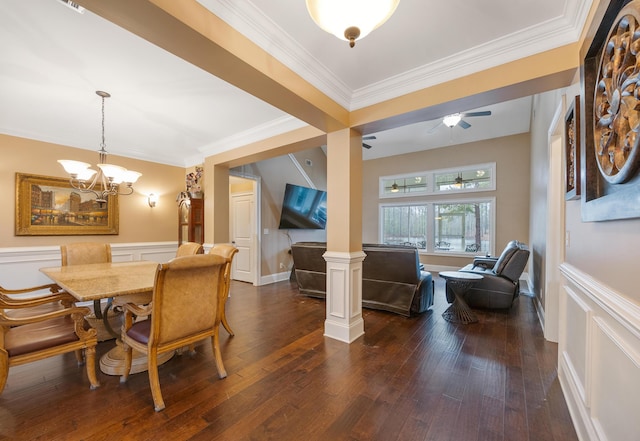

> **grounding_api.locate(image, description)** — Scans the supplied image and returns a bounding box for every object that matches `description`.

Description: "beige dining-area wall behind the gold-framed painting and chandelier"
[0,135,185,247]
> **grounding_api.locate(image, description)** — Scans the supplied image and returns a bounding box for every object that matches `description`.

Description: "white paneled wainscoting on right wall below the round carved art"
[558,264,640,441]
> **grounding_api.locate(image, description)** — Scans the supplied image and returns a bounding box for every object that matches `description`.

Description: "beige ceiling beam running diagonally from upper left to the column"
[77,0,349,132]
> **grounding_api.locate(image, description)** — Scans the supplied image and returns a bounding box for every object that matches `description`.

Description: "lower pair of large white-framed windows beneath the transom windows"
[380,198,495,255]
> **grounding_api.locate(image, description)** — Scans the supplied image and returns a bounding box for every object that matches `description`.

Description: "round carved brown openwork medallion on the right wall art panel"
[593,0,640,184]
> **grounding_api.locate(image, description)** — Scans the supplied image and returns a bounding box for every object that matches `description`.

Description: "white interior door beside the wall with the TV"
[230,193,256,284]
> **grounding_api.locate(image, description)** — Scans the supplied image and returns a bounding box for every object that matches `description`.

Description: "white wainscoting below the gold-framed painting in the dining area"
[0,242,178,289]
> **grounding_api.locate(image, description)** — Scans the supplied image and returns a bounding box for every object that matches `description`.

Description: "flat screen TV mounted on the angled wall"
[278,184,327,230]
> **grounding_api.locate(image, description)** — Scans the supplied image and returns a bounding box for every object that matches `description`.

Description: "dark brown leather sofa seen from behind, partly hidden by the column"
[291,242,433,317]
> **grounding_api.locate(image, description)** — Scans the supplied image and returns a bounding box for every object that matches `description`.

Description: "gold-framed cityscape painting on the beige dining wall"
[15,173,118,236]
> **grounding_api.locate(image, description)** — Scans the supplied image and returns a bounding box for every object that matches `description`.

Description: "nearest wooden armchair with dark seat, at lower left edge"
[0,290,100,393]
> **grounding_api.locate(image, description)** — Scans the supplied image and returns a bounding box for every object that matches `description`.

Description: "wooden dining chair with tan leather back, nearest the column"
[120,254,227,411]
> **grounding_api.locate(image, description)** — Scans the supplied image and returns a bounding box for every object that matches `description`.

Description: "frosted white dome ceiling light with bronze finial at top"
[306,0,400,47]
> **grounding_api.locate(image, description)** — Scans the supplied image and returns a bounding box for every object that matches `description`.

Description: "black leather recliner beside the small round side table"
[446,240,529,309]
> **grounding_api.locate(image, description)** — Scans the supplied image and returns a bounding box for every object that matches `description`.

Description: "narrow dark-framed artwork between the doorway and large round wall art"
[564,96,580,200]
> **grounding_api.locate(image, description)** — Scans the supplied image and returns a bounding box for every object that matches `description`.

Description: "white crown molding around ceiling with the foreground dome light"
[197,0,592,111]
